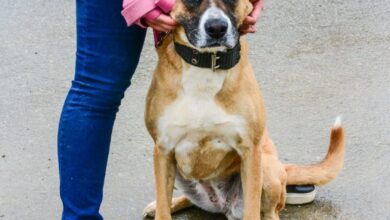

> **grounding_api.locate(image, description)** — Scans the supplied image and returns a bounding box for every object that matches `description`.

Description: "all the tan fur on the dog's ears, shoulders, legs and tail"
[145,0,344,220]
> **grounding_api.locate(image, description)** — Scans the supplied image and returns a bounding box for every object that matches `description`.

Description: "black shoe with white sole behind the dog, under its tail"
[286,185,316,205]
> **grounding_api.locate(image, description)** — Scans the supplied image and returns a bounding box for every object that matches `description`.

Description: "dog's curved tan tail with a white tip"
[285,116,345,185]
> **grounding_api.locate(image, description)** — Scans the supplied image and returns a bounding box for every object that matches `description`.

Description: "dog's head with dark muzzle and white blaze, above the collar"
[171,0,252,50]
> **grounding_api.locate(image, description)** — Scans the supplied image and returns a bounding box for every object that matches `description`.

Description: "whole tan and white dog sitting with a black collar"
[145,0,344,220]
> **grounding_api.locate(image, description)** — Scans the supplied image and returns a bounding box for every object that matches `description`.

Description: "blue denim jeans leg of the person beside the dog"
[58,0,145,220]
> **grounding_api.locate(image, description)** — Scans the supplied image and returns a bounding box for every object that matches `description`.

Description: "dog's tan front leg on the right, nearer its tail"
[241,146,262,220]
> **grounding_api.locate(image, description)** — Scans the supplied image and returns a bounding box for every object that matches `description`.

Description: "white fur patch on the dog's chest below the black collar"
[158,66,245,161]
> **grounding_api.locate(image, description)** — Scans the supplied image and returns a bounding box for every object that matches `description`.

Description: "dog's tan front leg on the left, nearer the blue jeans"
[153,145,176,220]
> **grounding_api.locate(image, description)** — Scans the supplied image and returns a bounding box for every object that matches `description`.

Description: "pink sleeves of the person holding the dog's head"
[122,0,263,43]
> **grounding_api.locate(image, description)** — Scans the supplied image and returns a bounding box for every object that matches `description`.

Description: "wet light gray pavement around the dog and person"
[0,0,390,220]
